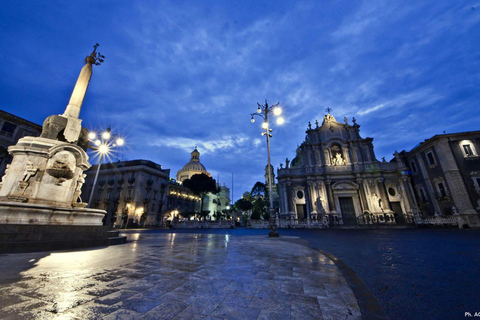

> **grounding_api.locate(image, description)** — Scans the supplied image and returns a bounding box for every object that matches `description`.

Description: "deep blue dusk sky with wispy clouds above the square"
[0,0,480,198]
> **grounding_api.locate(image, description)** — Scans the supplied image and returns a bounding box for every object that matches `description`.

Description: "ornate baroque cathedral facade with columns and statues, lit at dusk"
[277,113,416,225]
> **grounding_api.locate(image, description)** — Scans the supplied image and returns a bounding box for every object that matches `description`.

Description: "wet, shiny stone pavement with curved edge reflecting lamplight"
[0,234,362,320]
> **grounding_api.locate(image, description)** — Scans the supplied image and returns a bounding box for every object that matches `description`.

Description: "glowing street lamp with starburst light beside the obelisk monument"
[87,127,125,208]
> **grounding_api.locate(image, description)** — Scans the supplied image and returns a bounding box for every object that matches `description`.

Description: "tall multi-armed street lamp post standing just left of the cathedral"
[250,100,284,237]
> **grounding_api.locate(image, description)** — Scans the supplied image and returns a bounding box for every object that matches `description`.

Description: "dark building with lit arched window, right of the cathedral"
[401,131,480,227]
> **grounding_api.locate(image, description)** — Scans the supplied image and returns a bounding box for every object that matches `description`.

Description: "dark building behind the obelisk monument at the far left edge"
[0,110,42,177]
